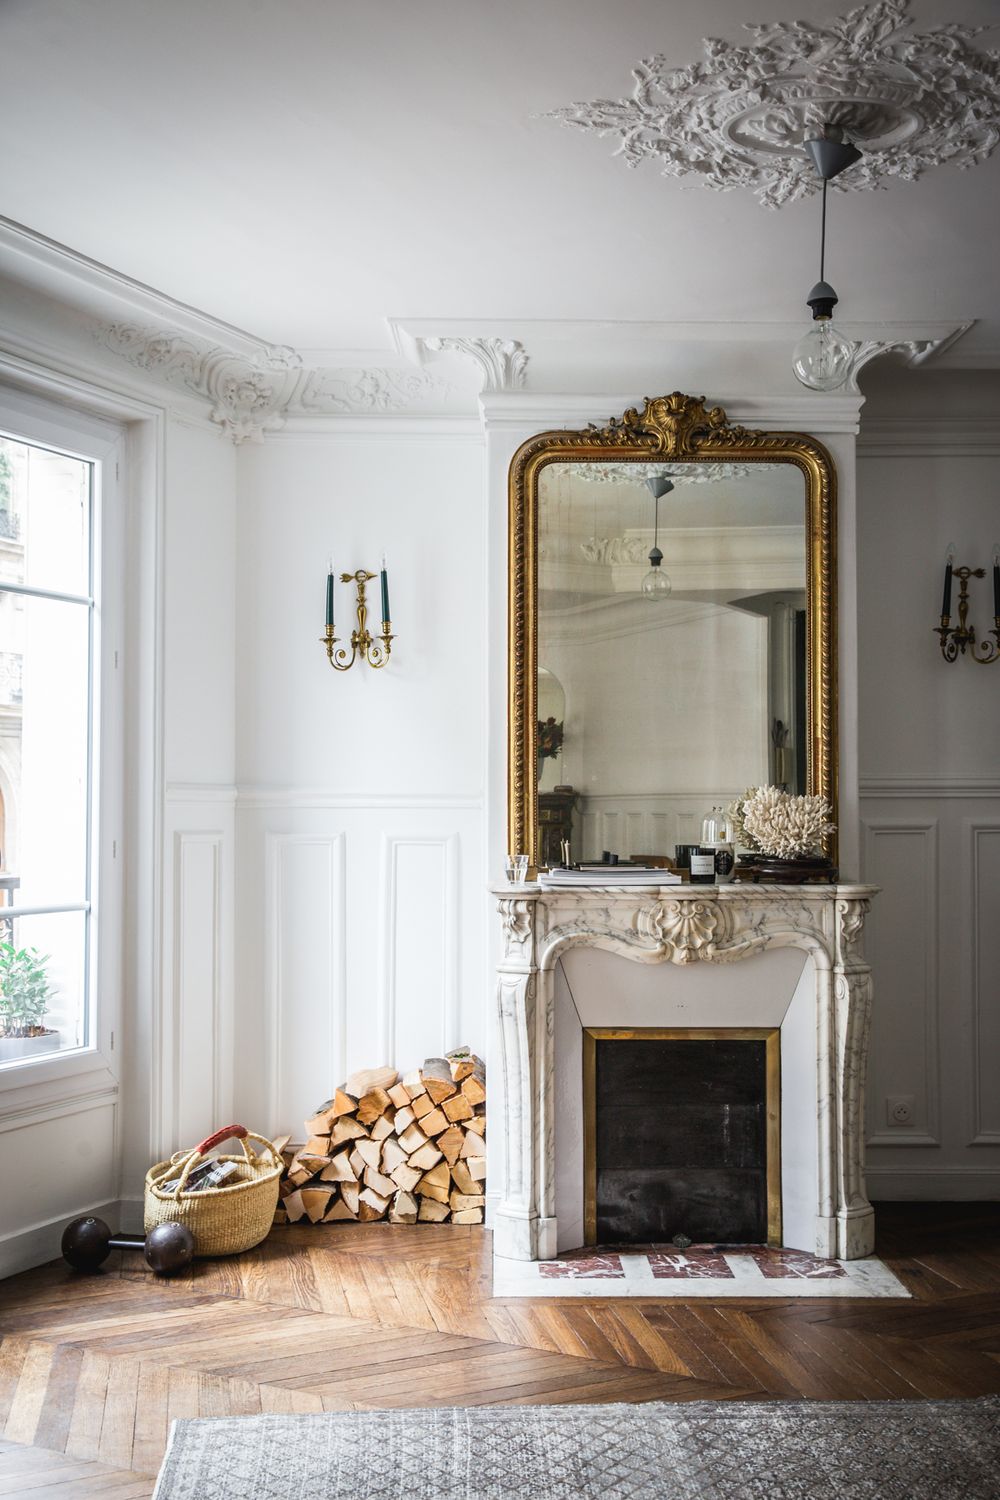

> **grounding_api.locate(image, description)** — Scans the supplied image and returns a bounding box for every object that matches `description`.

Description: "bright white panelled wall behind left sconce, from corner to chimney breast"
[235,419,490,1133]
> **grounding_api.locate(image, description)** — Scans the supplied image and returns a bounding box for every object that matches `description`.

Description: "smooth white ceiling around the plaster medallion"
[0,0,1000,363]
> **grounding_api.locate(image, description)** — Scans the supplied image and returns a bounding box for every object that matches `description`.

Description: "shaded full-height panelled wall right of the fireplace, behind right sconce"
[858,371,1000,1199]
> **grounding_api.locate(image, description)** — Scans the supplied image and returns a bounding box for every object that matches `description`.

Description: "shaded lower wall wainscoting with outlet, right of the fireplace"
[862,776,1000,1199]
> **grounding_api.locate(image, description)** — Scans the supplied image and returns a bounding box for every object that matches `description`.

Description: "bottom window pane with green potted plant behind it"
[0,908,87,1064]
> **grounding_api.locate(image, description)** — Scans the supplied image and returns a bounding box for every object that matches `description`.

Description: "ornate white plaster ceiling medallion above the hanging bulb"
[546,0,1000,209]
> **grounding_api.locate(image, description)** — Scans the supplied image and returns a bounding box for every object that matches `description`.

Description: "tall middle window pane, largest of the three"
[0,587,90,906]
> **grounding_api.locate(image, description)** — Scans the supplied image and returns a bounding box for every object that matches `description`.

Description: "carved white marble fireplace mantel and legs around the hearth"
[493,882,876,1260]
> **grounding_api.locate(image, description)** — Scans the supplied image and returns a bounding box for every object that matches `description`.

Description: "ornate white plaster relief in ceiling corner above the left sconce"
[93,323,451,443]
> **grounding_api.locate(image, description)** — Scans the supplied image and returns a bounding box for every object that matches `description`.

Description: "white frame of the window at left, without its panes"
[0,386,126,1095]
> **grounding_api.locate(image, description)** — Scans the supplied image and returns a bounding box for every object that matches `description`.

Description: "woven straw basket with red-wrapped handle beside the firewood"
[144,1125,282,1256]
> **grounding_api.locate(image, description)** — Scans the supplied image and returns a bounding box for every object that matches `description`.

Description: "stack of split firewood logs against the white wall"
[274,1049,486,1224]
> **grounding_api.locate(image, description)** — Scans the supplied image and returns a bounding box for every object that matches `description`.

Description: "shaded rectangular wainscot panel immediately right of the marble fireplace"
[862,818,942,1148]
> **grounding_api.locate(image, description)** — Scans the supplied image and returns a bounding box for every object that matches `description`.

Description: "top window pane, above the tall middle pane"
[0,437,93,594]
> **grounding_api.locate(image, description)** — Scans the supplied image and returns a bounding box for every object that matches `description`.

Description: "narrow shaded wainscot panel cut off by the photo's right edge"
[963,819,1000,1146]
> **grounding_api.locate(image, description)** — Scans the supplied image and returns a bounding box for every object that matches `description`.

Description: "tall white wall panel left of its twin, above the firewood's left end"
[264,831,348,1130]
